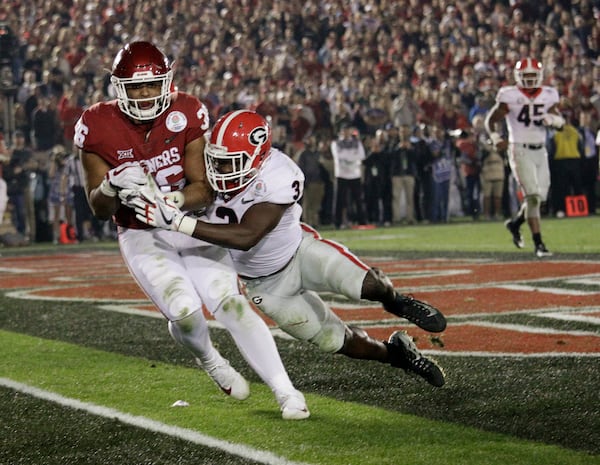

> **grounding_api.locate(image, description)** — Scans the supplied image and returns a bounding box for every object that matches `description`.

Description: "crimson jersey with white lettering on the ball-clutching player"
[73,92,209,229]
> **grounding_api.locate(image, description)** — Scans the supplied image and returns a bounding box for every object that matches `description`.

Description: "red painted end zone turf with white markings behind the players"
[0,253,600,354]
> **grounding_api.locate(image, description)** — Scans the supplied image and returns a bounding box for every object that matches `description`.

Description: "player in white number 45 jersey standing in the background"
[485,58,565,258]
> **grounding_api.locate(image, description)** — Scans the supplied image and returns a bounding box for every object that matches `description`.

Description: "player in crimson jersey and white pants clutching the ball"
[74,42,309,419]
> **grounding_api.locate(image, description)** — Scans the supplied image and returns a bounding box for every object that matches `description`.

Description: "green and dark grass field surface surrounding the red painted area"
[0,217,600,465]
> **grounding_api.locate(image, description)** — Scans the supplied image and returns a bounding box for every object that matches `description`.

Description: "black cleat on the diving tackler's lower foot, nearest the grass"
[384,331,446,387]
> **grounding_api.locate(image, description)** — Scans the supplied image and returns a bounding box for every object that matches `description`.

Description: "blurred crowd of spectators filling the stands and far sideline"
[0,0,600,243]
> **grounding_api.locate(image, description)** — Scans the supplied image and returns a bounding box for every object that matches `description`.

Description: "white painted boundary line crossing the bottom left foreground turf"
[0,378,309,465]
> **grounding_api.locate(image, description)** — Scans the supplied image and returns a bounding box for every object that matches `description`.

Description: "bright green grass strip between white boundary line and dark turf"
[0,331,600,465]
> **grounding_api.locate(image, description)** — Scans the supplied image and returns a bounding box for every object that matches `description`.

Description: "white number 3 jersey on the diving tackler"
[206,149,304,277]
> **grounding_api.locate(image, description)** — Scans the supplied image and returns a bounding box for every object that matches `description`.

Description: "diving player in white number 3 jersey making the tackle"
[134,110,446,387]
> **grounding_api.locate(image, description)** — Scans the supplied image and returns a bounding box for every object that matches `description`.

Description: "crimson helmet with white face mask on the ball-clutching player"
[110,42,173,121]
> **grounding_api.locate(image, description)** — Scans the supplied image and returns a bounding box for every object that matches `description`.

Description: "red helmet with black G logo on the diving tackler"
[204,110,271,194]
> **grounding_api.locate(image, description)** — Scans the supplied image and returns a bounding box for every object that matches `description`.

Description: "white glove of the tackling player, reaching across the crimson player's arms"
[130,189,196,236]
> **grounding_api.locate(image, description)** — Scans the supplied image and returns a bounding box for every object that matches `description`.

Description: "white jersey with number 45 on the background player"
[496,86,559,145]
